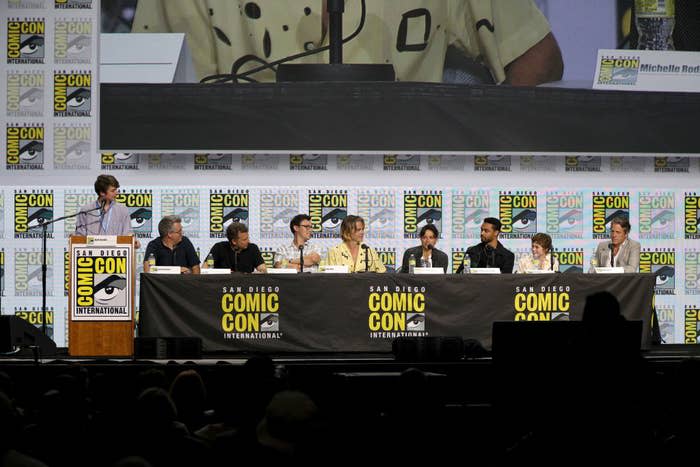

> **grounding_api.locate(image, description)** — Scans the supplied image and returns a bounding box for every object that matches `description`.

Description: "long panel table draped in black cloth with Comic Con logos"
[139,273,655,353]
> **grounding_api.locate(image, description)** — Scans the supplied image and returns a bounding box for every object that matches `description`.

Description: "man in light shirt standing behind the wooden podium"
[75,175,141,248]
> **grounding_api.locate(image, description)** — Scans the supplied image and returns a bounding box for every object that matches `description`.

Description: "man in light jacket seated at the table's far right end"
[590,217,641,272]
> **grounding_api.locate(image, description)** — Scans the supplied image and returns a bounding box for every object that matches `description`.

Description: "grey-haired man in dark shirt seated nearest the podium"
[143,216,199,274]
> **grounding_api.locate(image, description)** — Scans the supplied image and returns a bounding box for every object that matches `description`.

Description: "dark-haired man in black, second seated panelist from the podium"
[203,222,267,272]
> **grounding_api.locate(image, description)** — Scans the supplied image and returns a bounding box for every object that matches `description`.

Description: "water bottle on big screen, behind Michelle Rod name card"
[634,0,676,50]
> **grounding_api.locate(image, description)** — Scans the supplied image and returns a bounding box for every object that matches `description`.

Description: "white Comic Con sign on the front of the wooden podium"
[72,248,130,319]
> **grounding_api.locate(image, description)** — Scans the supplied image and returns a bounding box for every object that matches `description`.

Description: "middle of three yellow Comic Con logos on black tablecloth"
[367,285,428,339]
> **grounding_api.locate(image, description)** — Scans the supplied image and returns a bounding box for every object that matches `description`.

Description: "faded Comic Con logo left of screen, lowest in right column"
[53,123,92,169]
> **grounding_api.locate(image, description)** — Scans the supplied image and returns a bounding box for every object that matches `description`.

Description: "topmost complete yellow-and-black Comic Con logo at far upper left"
[7,18,46,65]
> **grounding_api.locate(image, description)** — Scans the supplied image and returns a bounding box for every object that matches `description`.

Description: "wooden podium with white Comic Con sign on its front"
[68,235,136,357]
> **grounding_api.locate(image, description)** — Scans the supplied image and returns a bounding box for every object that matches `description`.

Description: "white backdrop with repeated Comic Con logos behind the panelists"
[0,0,700,346]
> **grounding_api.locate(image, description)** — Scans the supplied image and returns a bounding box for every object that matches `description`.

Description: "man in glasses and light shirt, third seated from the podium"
[275,214,321,272]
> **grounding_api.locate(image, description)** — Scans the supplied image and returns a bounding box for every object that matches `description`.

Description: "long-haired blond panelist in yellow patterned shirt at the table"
[328,215,386,272]
